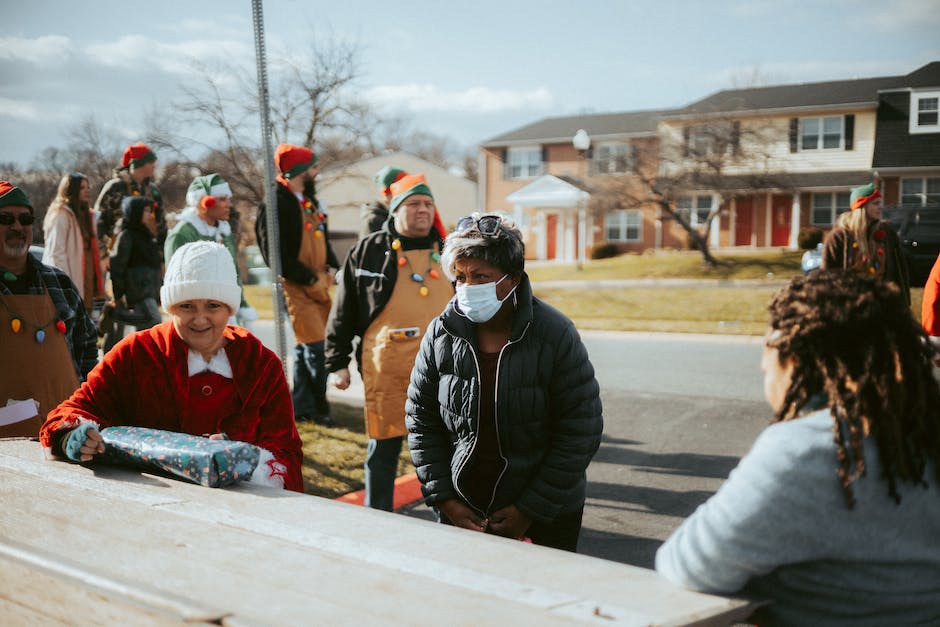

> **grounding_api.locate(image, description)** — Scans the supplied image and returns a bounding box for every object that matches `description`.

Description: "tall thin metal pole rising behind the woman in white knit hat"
[251,0,287,374]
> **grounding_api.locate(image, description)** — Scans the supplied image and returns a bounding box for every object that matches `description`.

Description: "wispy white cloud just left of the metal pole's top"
[86,35,254,75]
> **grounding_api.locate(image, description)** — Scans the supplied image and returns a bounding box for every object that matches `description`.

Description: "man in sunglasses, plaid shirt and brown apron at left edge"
[0,181,98,437]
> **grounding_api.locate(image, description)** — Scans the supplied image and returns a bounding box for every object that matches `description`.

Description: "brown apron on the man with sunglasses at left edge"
[0,293,78,437]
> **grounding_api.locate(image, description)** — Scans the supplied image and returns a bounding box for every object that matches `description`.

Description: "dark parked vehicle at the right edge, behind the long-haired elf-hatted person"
[882,204,940,287]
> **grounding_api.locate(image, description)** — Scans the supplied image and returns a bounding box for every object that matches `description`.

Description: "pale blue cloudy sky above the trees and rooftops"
[0,0,940,165]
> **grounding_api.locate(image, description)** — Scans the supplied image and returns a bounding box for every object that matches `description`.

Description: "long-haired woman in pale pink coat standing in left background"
[42,172,104,312]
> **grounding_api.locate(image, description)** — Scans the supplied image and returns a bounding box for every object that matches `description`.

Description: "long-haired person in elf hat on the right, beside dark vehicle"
[822,184,911,305]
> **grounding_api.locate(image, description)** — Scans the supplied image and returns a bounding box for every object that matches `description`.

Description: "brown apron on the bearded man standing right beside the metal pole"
[284,207,332,344]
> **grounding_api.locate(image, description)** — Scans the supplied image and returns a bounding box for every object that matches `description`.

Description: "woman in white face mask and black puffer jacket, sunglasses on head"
[405,214,603,551]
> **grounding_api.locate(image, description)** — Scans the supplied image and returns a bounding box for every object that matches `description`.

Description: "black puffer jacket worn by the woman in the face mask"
[405,275,603,523]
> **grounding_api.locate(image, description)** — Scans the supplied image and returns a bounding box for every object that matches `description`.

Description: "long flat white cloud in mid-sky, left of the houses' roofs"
[365,83,554,113]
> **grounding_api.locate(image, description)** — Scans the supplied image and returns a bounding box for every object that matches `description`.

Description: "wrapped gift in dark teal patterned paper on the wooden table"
[100,427,260,488]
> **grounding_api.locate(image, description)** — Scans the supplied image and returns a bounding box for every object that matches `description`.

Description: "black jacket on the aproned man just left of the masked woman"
[324,222,442,373]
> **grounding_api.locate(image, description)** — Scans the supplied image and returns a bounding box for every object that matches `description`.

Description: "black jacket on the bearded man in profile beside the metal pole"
[255,183,339,285]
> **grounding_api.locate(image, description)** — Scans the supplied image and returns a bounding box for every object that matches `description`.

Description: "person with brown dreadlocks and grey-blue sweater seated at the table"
[656,270,940,626]
